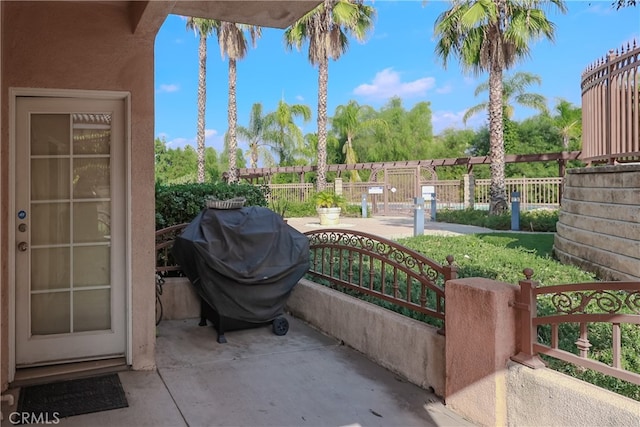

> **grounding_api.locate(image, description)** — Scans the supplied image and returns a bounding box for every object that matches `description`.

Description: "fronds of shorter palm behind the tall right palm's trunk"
[462,71,549,124]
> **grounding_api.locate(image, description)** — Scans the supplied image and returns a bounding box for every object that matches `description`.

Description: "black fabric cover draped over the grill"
[172,206,309,323]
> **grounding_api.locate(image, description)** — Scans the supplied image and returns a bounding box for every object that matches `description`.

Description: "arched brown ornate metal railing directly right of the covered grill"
[305,229,457,320]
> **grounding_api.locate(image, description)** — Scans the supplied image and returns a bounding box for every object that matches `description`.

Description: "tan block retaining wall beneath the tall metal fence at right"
[554,164,640,280]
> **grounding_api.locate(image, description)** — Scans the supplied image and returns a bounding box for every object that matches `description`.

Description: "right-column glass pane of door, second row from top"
[73,158,111,199]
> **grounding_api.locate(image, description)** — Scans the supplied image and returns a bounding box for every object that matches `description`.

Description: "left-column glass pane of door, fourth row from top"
[31,248,71,291]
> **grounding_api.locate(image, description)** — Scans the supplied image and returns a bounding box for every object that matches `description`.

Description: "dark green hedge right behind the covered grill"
[156,182,269,230]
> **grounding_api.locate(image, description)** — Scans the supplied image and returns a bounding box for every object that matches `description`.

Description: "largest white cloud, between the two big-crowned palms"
[353,68,436,99]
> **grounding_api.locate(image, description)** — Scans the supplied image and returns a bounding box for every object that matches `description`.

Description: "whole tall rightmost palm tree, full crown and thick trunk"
[435,0,566,214]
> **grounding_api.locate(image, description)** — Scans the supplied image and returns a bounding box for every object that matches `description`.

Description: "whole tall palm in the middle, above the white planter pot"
[284,0,375,190]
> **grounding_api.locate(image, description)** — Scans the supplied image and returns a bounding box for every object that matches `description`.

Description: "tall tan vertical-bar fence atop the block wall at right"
[581,40,640,164]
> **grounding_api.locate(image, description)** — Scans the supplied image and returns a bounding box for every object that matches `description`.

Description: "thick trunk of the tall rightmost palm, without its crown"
[489,64,508,215]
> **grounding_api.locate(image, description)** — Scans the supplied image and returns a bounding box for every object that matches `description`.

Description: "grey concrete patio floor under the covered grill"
[22,316,472,427]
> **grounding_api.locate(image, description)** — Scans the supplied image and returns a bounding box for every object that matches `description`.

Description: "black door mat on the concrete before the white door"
[17,374,129,420]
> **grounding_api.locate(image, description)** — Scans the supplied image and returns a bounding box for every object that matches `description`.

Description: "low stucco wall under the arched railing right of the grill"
[287,279,445,396]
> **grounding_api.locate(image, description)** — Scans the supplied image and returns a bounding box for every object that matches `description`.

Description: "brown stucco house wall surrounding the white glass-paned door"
[0,2,160,388]
